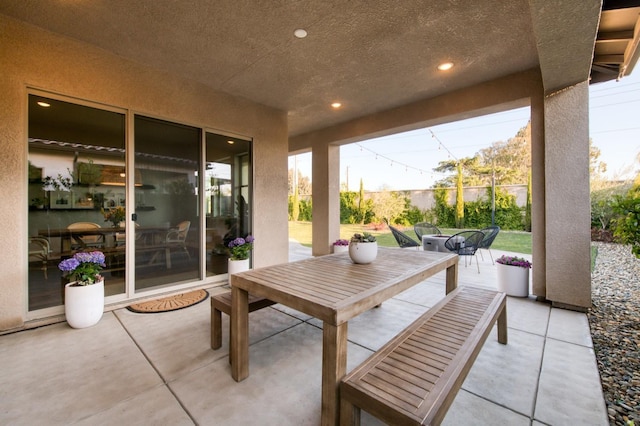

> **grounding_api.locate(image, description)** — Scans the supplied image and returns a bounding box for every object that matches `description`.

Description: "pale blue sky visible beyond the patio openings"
[289,71,640,191]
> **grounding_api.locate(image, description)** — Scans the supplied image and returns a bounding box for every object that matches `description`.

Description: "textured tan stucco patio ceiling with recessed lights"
[0,0,612,135]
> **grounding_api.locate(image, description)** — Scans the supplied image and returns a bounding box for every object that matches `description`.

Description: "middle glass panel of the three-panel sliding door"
[134,115,202,291]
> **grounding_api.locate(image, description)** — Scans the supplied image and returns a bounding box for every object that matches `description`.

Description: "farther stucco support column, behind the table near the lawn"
[311,144,340,256]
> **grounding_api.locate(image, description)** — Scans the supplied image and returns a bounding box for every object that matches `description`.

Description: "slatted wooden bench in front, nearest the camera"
[340,287,507,425]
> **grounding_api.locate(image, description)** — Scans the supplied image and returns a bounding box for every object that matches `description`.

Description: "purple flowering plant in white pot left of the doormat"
[58,251,105,328]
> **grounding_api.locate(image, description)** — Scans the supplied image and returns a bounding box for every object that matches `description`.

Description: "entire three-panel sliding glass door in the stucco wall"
[28,95,253,311]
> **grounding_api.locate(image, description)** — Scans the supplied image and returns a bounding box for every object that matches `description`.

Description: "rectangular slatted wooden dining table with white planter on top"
[230,247,458,425]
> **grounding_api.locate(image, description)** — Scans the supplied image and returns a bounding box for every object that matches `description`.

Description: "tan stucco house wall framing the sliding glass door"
[0,15,288,330]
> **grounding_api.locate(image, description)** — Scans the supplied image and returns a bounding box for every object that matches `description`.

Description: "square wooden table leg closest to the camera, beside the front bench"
[321,322,348,426]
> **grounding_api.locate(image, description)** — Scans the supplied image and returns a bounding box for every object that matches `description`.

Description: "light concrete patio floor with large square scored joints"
[0,243,608,426]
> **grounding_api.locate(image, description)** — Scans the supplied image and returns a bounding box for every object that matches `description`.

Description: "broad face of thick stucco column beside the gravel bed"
[534,81,591,310]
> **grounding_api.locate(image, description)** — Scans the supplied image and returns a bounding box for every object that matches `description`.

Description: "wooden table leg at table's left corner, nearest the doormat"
[229,287,249,382]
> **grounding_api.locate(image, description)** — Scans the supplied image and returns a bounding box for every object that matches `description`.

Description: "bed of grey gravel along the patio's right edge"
[588,243,640,426]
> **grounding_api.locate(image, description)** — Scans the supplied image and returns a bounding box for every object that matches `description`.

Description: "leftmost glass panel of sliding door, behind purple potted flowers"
[28,94,127,311]
